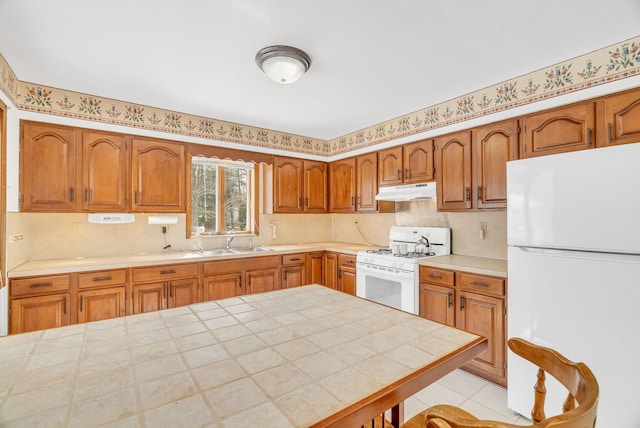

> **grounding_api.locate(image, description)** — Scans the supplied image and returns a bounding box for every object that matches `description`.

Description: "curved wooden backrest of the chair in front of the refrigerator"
[508,338,599,428]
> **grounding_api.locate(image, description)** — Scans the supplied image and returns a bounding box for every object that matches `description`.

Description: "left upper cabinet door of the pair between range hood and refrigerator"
[435,131,471,211]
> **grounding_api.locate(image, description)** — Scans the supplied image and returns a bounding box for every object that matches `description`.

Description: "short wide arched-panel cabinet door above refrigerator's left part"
[521,101,597,158]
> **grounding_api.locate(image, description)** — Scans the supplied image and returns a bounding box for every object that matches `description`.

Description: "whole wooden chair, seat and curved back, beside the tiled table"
[401,338,599,428]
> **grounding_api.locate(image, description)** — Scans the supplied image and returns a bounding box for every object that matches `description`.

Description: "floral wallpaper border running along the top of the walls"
[0,36,640,157]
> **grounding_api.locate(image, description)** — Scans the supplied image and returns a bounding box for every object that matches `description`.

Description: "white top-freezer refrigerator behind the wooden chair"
[507,143,640,428]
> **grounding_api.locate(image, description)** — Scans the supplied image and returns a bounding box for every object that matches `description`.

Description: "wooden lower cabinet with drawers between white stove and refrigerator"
[420,266,507,386]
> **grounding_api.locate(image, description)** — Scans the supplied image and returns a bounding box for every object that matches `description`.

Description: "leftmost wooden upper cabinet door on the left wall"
[20,122,79,212]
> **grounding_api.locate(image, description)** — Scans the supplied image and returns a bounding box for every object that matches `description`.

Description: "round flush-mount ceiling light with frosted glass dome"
[256,45,311,85]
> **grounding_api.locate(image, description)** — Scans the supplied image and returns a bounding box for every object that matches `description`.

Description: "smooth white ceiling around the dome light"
[0,0,640,139]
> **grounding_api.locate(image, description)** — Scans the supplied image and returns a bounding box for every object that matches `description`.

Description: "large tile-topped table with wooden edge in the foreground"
[0,285,487,428]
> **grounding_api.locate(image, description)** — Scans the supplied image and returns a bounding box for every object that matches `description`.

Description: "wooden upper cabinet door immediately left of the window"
[131,138,186,212]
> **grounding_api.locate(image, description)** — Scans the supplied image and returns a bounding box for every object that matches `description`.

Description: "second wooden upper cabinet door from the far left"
[80,132,129,212]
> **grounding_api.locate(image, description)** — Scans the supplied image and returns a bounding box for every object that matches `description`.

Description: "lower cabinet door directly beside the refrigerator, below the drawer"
[456,292,506,378]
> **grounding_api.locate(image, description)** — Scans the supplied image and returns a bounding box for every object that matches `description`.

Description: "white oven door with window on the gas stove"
[356,263,418,315]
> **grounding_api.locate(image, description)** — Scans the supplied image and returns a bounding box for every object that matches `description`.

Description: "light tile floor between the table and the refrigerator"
[404,369,533,425]
